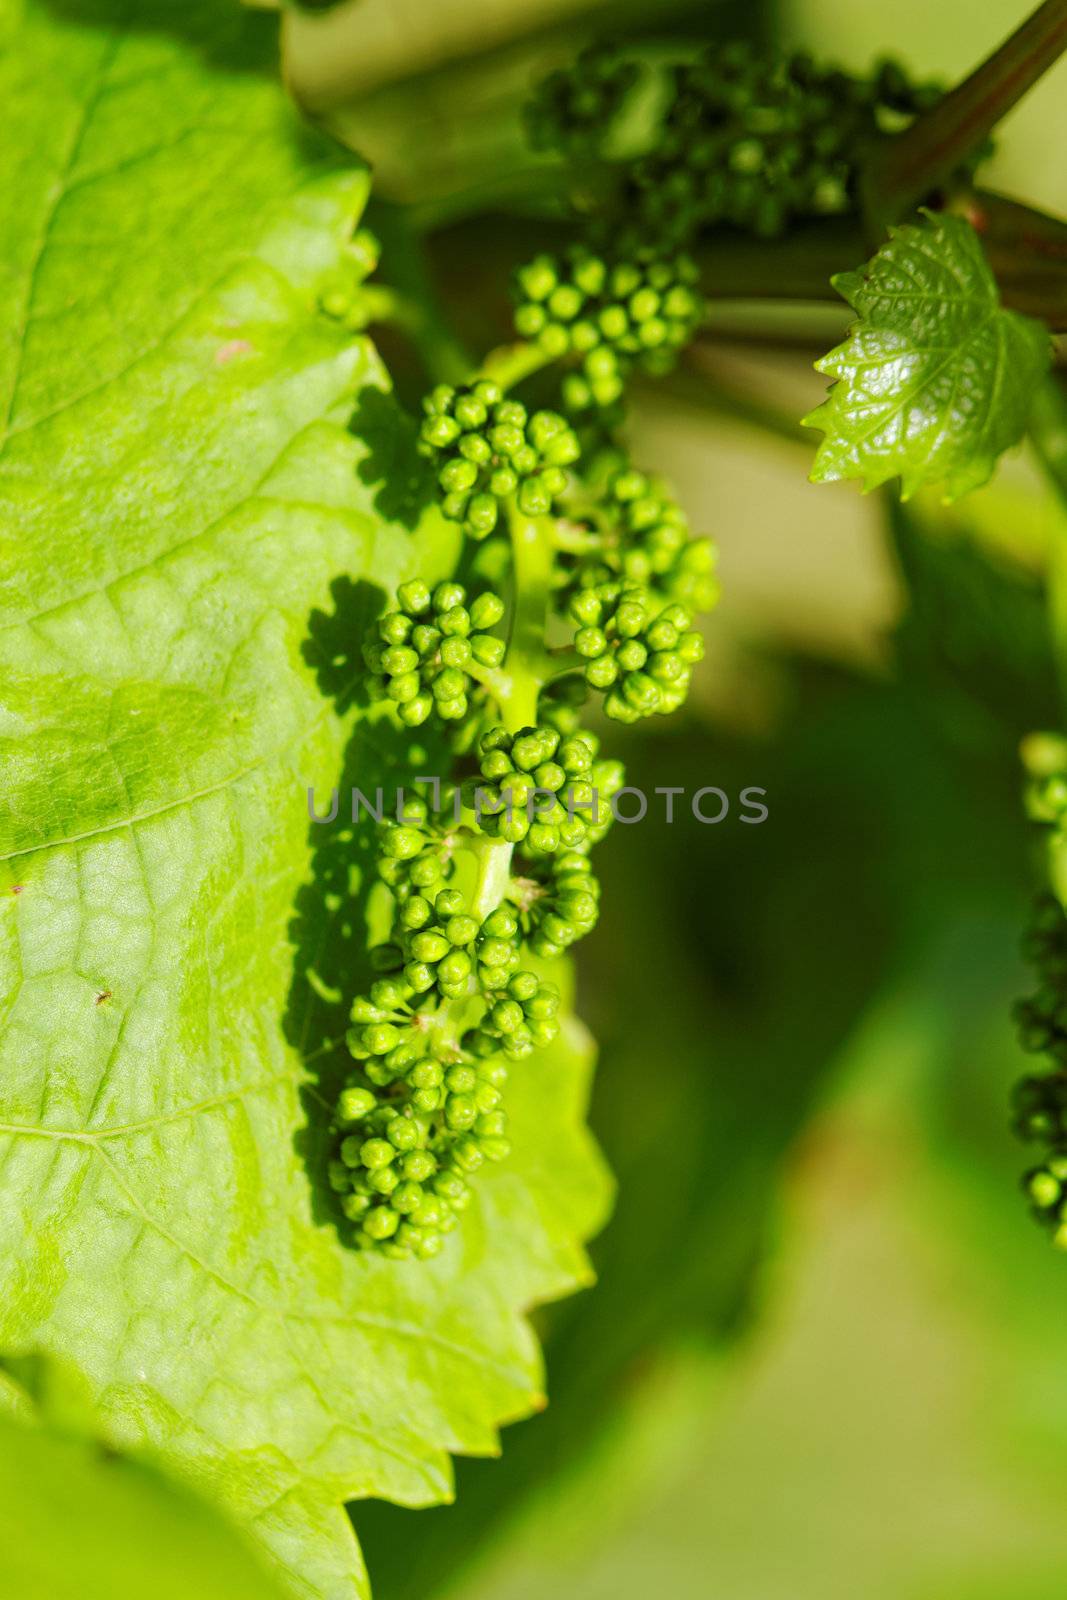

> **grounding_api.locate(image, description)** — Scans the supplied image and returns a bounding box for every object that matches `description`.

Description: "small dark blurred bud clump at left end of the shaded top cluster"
[523,43,640,157]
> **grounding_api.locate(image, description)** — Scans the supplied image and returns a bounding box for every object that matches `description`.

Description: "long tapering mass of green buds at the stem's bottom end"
[330,802,560,1259]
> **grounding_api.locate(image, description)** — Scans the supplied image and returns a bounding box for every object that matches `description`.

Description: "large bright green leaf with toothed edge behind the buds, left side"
[0,0,606,1600]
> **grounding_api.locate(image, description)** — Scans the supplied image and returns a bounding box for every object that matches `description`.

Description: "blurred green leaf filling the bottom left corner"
[0,1362,280,1600]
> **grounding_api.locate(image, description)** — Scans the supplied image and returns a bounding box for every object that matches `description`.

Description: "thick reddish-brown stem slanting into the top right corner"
[862,0,1067,240]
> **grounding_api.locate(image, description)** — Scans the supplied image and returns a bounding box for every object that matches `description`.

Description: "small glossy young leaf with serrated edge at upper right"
[805,214,1051,501]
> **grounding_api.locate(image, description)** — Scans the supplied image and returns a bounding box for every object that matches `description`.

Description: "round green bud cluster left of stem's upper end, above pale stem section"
[419,379,579,539]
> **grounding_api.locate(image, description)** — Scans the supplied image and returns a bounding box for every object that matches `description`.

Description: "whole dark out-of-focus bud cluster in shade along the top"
[528,40,989,243]
